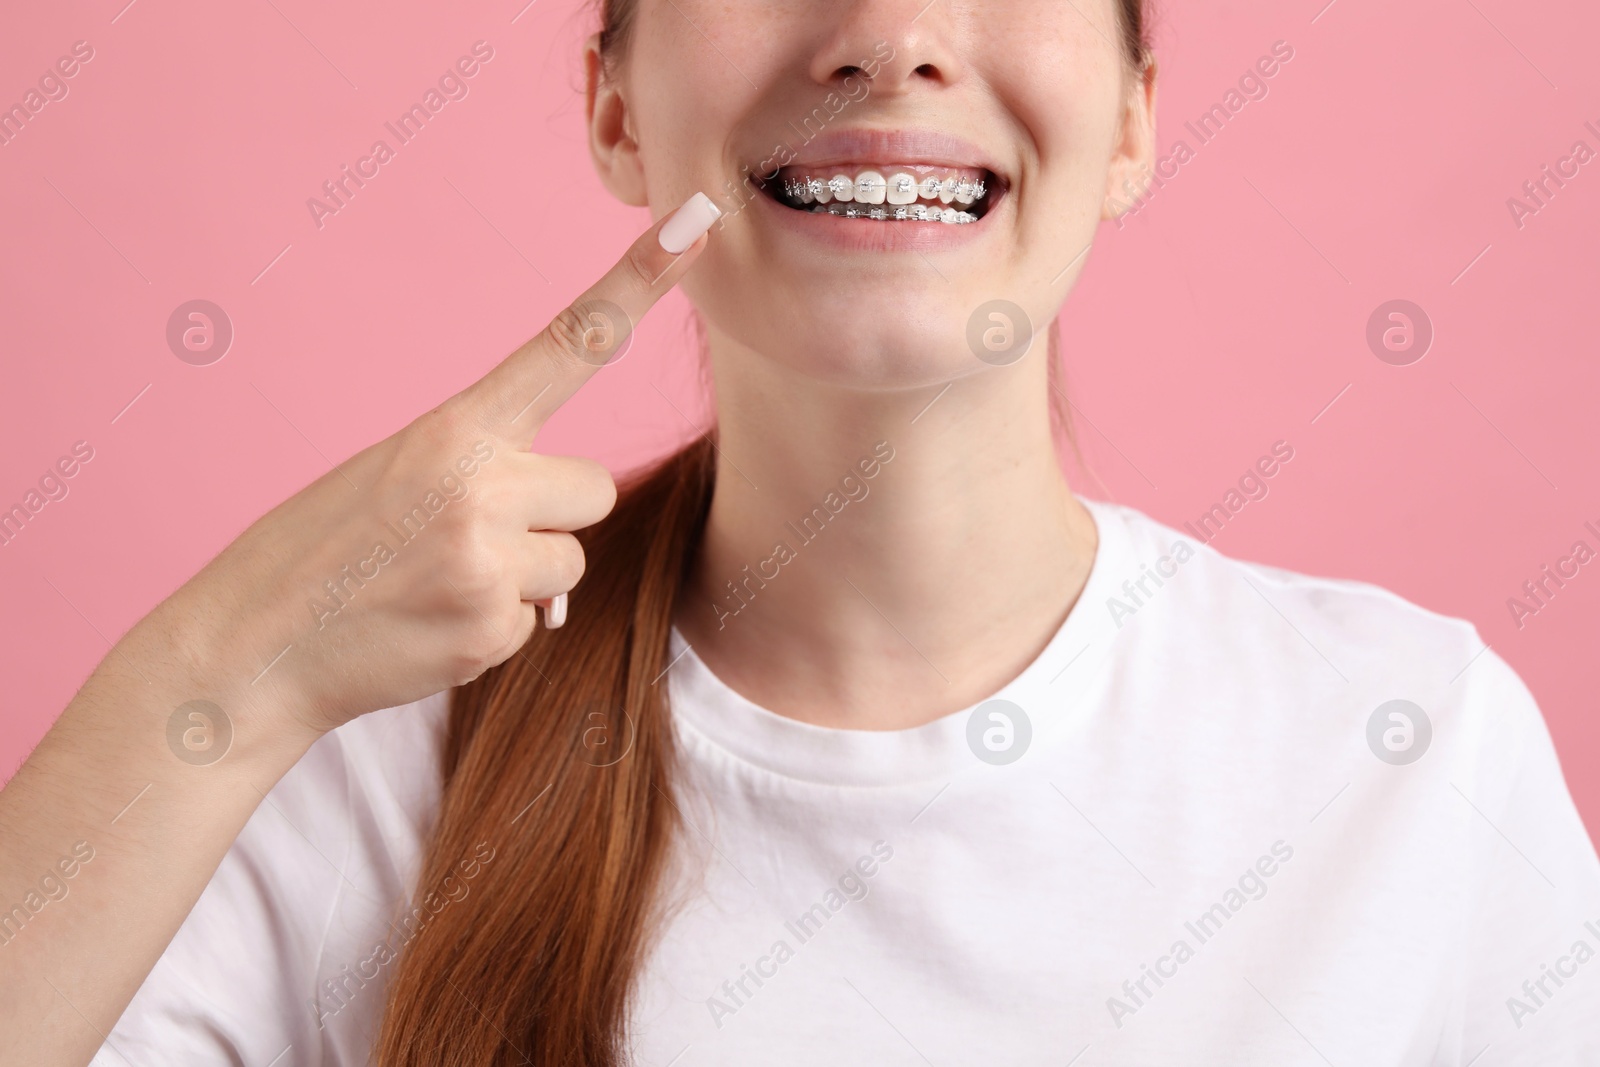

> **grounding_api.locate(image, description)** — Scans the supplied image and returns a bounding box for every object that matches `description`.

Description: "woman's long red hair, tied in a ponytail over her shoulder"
[374,0,1147,1067]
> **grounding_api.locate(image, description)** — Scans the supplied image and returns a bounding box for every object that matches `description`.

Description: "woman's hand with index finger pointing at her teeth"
[154,195,717,736]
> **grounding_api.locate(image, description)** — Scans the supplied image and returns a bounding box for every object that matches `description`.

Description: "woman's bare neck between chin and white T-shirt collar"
[677,326,1096,729]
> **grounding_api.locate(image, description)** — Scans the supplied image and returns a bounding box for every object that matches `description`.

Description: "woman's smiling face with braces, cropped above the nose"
[589,0,1154,389]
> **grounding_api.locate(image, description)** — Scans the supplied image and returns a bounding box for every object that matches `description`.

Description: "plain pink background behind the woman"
[0,0,1600,830]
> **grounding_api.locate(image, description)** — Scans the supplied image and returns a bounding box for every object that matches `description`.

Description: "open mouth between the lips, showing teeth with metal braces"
[762,163,1005,226]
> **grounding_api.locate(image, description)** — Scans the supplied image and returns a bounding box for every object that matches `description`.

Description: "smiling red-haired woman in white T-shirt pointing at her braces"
[0,0,1600,1064]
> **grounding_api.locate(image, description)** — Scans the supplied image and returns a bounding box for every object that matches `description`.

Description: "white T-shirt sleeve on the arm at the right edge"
[1459,653,1600,1067]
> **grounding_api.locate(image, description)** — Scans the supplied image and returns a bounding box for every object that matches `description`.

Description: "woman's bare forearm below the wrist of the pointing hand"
[0,611,314,1064]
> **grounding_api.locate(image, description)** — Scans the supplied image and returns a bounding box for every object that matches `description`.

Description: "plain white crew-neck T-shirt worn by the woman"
[94,502,1600,1067]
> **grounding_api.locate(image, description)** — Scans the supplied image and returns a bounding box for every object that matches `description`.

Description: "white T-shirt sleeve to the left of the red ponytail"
[91,697,445,1067]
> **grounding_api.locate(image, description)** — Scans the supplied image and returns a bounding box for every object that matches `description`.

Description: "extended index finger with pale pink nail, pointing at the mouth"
[462,192,722,440]
